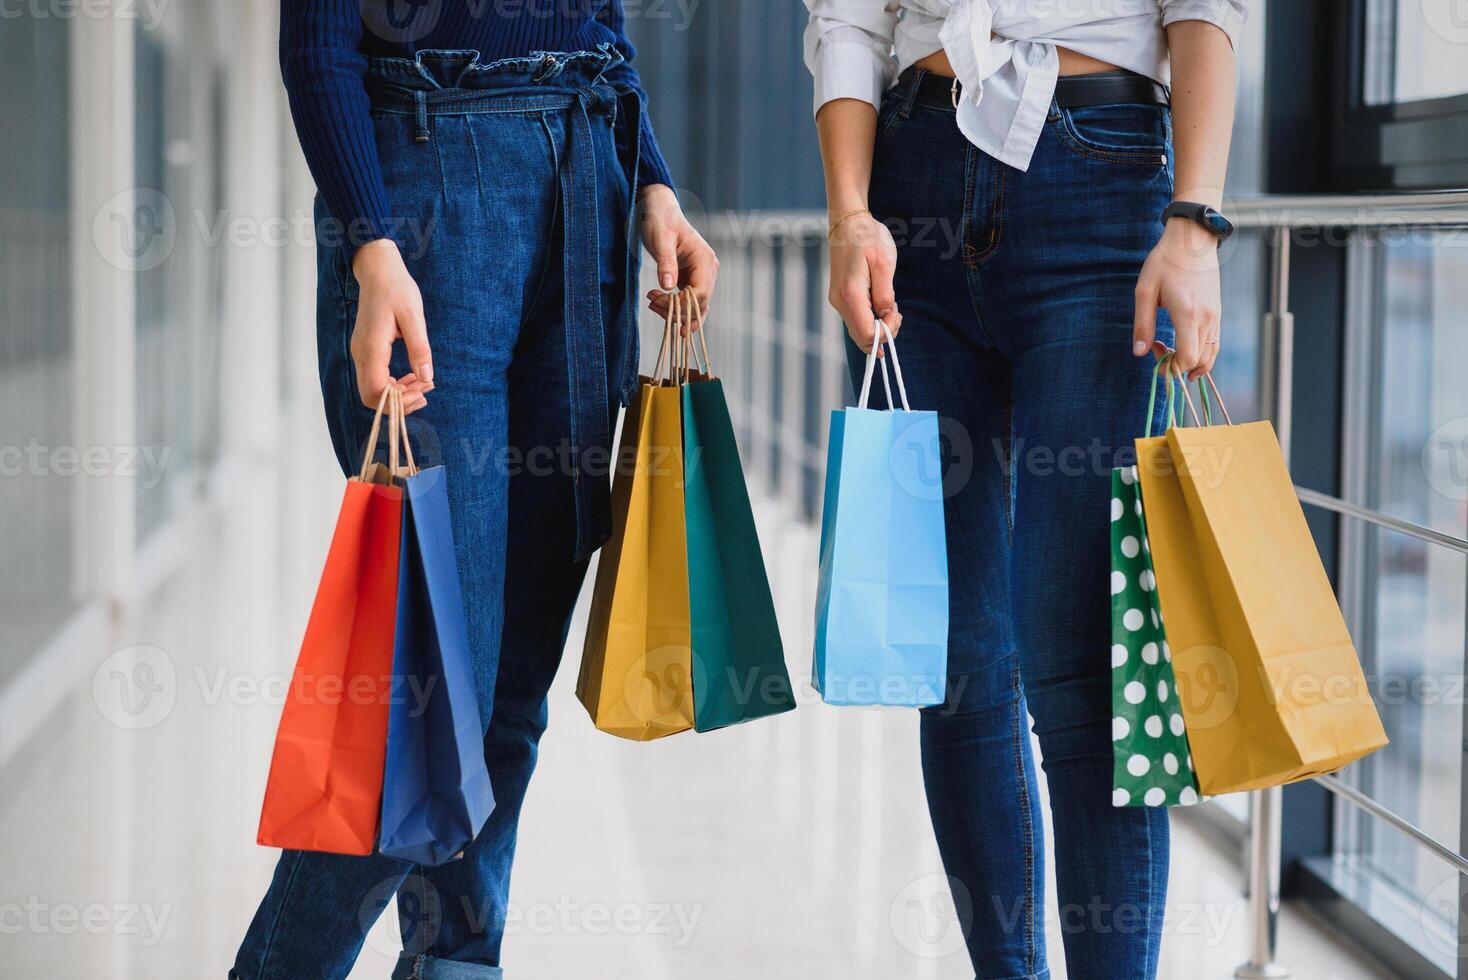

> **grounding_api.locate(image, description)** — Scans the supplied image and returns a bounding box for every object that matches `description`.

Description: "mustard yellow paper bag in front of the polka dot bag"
[1136,369,1387,795]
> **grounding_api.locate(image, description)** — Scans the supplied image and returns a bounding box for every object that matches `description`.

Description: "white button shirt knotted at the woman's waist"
[804,0,1245,170]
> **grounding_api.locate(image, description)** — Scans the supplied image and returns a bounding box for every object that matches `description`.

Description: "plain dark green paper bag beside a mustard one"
[683,356,796,732]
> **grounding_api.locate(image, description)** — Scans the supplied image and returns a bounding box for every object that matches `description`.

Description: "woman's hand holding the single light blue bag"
[828,213,903,356]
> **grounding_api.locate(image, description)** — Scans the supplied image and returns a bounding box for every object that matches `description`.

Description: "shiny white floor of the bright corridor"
[0,416,1397,980]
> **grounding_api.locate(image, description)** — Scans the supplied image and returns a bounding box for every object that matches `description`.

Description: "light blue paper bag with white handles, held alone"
[813,321,948,707]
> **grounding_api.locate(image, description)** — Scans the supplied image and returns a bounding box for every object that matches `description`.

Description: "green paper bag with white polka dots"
[1111,359,1199,807]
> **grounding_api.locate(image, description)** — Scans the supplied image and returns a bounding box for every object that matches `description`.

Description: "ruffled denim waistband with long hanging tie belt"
[367,44,643,559]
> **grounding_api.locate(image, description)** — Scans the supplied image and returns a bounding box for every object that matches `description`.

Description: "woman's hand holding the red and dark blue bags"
[351,238,433,414]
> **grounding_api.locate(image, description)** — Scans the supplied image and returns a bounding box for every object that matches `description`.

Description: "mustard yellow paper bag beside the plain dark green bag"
[575,379,693,741]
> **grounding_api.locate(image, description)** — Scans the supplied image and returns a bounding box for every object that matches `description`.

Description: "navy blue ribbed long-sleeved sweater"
[280,0,672,246]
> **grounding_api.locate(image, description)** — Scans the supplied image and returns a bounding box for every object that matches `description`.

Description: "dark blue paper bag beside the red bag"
[377,456,495,864]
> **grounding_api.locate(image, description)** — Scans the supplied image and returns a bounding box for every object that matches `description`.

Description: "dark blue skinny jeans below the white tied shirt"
[849,70,1171,980]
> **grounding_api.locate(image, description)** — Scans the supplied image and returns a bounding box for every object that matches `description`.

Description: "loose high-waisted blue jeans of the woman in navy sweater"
[230,48,640,980]
